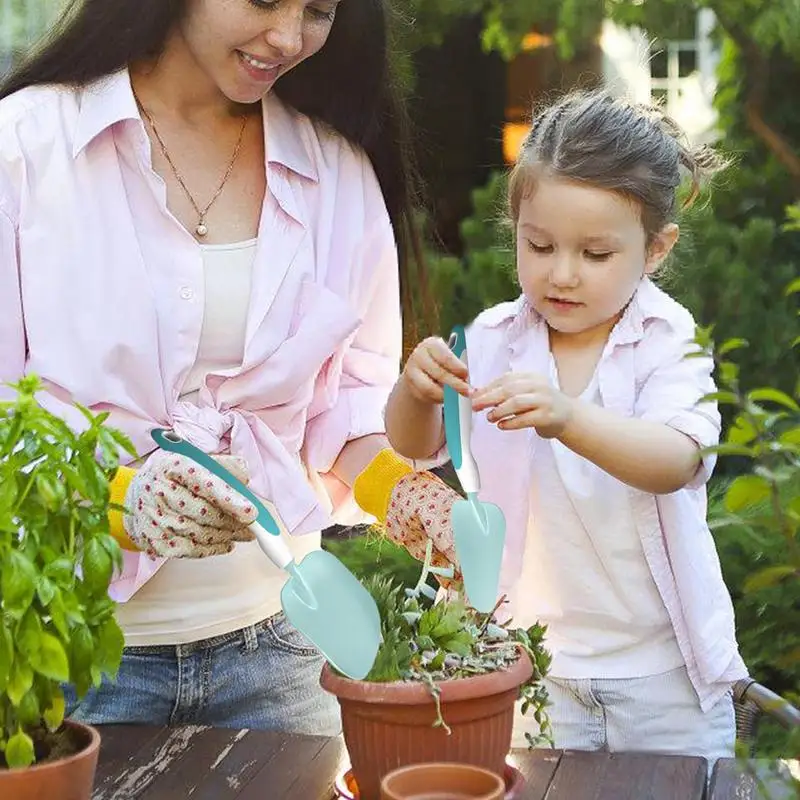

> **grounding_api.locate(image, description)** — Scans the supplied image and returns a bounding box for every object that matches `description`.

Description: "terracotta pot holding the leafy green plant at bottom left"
[0,720,100,800]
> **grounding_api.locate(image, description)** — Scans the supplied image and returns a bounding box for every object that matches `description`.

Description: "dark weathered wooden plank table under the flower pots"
[93,725,790,800]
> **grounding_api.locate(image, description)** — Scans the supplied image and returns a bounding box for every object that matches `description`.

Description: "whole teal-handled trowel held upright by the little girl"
[444,325,506,614]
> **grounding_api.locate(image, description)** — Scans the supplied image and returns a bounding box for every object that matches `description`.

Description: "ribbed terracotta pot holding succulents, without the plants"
[320,651,533,800]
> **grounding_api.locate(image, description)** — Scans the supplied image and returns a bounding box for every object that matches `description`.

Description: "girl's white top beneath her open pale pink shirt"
[514,354,684,678]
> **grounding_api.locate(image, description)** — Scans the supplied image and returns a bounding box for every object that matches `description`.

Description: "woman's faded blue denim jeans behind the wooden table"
[64,613,341,736]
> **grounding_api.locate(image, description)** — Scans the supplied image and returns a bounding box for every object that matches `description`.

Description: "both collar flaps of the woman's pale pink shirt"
[72,68,319,181]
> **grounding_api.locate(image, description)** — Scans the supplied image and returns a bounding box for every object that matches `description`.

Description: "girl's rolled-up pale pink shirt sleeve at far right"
[635,323,722,488]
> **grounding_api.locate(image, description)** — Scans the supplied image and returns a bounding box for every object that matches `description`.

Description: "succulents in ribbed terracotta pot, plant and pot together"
[320,542,552,800]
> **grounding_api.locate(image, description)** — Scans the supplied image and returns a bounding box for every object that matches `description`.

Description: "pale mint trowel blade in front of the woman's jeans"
[281,550,382,680]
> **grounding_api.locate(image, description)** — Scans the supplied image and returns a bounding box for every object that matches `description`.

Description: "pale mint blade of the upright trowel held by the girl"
[452,500,506,614]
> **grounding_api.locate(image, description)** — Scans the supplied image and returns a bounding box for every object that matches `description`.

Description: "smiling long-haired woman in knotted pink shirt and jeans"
[0,0,432,734]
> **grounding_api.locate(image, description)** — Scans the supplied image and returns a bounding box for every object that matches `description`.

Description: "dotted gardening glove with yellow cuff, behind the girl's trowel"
[353,449,462,588]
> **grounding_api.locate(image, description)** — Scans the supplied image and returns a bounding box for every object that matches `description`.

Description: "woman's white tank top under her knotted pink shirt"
[117,239,321,646]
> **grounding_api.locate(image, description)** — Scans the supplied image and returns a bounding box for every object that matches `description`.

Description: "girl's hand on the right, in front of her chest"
[472,372,574,439]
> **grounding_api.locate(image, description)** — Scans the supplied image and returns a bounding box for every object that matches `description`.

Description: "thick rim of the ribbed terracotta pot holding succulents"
[320,646,533,705]
